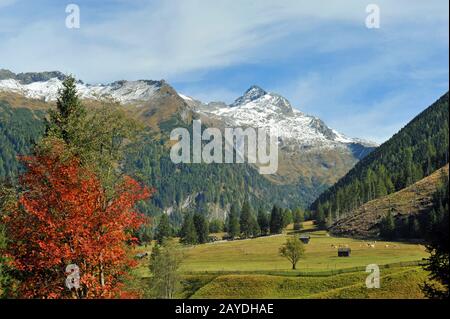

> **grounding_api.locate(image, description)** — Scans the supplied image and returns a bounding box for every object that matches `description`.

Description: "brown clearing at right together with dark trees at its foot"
[329,165,448,240]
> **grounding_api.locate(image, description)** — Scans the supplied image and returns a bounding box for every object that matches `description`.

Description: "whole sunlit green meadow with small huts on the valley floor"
[137,223,428,299]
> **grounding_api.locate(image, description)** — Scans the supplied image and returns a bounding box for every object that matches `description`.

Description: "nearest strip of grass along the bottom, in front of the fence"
[184,267,426,299]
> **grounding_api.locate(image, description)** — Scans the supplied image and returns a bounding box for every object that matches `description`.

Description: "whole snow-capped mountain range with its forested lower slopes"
[0,70,377,221]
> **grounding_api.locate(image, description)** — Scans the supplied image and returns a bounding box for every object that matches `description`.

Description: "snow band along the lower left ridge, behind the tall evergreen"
[0,78,163,104]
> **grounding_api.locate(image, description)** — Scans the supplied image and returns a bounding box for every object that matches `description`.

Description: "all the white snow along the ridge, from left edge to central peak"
[0,70,377,152]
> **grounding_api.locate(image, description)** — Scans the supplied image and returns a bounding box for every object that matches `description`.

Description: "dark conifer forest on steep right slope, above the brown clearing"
[312,92,449,226]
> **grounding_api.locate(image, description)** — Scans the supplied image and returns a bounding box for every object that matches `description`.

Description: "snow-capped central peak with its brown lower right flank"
[184,85,377,186]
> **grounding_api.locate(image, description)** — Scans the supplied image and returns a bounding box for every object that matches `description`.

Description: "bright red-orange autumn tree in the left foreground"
[6,144,151,298]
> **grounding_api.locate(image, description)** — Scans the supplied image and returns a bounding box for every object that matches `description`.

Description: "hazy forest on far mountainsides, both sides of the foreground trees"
[0,100,317,224]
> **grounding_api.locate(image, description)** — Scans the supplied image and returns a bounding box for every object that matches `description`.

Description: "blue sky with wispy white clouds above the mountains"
[0,0,449,142]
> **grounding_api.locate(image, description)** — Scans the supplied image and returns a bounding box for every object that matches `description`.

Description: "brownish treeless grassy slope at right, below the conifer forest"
[330,164,449,237]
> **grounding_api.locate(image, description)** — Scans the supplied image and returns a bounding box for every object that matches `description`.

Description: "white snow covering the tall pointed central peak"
[191,86,376,150]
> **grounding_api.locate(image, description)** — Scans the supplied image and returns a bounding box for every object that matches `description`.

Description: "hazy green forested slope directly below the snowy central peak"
[124,119,317,223]
